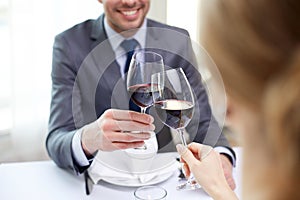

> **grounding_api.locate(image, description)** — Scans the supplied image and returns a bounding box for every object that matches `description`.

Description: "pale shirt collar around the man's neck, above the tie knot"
[104,17,147,52]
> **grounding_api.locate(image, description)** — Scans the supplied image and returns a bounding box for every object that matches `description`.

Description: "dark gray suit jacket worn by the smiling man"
[46,15,234,172]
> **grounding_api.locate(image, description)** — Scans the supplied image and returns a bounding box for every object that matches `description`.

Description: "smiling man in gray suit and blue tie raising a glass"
[46,0,235,188]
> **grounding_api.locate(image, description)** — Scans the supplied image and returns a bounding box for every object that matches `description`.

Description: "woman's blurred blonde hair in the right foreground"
[201,0,300,199]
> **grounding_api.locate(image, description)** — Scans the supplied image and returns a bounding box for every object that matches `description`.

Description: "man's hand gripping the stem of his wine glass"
[81,109,155,155]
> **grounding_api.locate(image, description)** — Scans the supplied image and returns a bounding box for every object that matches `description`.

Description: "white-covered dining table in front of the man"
[0,147,242,200]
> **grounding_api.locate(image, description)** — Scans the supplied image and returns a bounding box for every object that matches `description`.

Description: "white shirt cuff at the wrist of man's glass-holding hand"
[72,129,90,167]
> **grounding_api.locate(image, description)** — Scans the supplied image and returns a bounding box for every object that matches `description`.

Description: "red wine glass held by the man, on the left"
[127,50,164,150]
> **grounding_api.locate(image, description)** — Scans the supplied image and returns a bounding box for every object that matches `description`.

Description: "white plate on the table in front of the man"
[89,152,179,186]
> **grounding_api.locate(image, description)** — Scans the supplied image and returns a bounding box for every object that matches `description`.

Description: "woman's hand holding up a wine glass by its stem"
[176,143,237,199]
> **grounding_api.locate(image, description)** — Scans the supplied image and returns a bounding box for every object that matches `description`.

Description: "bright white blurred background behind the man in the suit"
[0,0,239,163]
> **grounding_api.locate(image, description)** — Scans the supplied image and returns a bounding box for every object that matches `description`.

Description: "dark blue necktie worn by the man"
[121,39,141,112]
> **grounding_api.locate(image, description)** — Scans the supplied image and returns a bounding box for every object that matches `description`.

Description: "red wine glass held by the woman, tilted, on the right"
[152,68,200,190]
